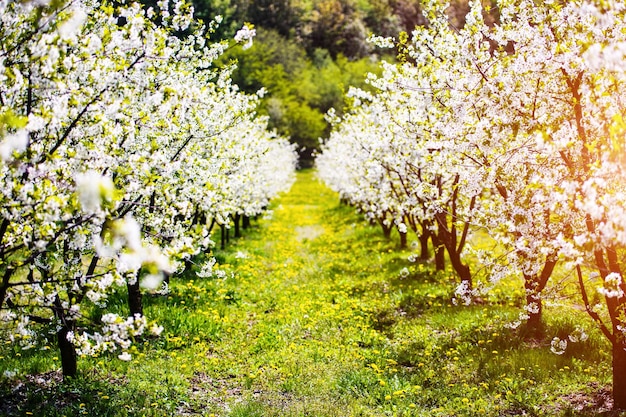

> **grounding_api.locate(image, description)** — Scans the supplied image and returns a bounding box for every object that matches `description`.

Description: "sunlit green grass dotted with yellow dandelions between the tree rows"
[0,171,611,417]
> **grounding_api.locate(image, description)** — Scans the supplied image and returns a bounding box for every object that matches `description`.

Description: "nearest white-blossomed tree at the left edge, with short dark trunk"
[0,2,171,375]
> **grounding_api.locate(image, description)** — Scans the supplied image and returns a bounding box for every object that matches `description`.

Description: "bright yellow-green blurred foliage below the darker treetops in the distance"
[223,27,378,166]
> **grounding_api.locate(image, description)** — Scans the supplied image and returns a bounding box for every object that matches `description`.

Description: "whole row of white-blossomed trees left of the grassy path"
[0,0,295,375]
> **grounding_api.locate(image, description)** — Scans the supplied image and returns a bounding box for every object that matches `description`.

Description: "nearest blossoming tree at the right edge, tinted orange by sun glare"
[492,3,626,409]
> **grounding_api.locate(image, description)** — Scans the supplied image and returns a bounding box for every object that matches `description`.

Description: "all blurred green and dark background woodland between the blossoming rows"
[183,0,486,166]
